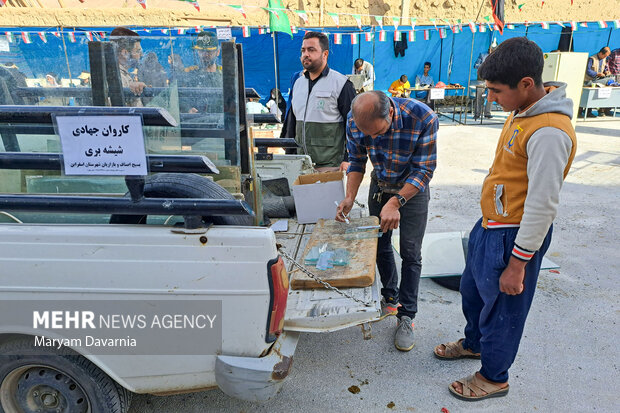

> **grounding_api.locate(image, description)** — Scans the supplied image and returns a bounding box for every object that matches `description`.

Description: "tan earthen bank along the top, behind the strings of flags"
[0,0,620,27]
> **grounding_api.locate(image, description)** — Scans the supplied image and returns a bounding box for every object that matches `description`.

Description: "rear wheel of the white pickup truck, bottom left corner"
[0,338,133,413]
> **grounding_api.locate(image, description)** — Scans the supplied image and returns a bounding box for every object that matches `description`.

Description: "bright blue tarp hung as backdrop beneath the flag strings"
[0,23,620,100]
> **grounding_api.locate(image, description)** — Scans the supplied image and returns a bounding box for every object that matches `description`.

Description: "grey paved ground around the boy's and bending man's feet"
[131,116,620,413]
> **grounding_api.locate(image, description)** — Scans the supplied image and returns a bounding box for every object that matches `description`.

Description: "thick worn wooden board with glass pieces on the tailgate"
[291,217,379,290]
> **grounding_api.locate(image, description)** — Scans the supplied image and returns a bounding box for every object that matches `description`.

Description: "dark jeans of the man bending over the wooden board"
[368,179,430,318]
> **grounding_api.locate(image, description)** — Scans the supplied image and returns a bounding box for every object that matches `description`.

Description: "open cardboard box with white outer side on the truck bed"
[293,172,344,224]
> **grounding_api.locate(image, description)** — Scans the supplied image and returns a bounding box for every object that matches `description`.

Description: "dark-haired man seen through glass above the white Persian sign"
[110,27,146,107]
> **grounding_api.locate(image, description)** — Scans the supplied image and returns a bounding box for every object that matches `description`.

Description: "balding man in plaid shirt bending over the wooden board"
[336,91,439,351]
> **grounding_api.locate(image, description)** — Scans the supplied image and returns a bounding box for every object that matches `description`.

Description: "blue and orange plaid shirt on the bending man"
[347,98,439,192]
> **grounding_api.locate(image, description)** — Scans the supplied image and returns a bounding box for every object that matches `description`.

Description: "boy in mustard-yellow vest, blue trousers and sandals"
[435,37,577,401]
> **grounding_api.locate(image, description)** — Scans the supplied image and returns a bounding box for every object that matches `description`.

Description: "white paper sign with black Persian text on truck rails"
[56,116,147,175]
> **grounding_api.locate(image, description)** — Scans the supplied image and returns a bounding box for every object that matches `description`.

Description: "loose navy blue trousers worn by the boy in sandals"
[461,220,553,383]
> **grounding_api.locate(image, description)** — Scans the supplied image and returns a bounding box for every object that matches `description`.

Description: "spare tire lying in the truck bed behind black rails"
[110,173,254,226]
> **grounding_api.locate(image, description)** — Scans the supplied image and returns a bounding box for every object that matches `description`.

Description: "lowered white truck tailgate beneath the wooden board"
[276,220,381,333]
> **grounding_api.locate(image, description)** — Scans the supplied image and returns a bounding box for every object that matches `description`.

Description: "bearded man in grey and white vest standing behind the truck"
[280,32,355,171]
